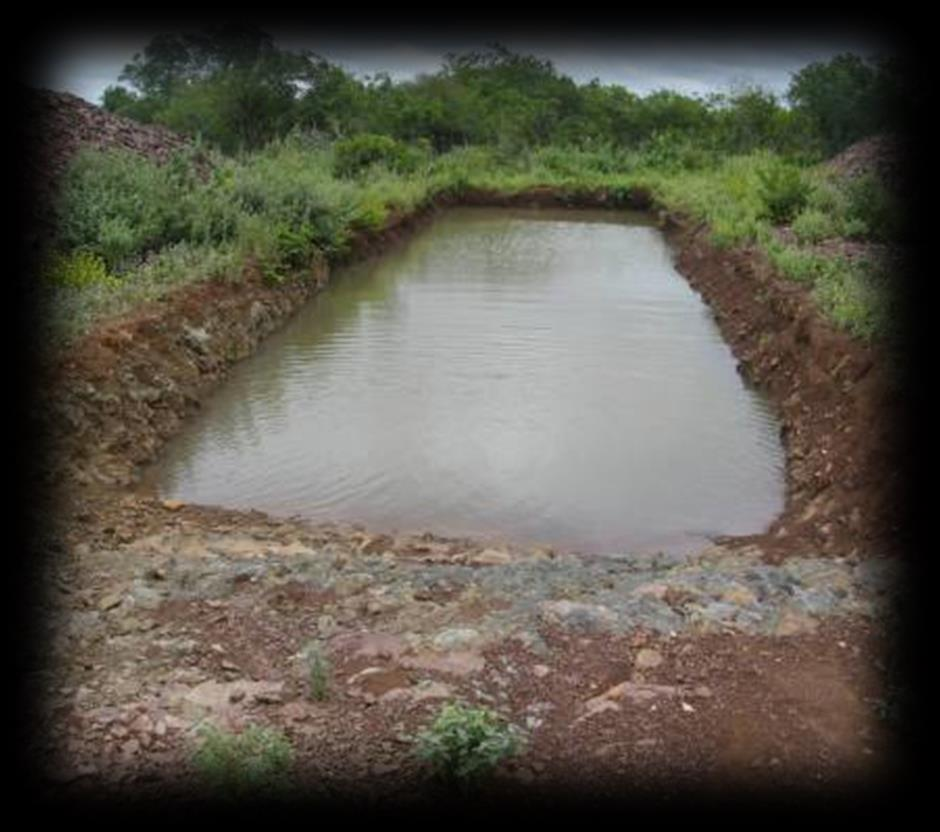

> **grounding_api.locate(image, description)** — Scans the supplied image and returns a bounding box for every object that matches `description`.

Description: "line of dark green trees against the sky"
[102,25,913,156]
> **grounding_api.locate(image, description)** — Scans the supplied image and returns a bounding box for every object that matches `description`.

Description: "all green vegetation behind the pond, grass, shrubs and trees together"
[47,27,907,336]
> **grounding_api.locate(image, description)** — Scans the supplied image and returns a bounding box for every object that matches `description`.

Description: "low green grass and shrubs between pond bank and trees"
[44,136,899,341]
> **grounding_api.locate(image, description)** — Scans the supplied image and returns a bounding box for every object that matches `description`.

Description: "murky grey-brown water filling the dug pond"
[145,208,783,552]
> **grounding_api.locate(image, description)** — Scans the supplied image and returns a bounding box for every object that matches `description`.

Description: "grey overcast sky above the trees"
[28,26,884,104]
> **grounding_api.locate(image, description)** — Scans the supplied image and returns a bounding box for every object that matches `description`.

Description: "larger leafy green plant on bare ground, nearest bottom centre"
[416,703,523,788]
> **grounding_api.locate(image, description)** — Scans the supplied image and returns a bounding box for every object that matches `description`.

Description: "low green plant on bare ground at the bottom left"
[193,724,294,797]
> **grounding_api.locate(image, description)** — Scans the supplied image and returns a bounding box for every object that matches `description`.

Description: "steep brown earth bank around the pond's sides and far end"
[42,187,899,561]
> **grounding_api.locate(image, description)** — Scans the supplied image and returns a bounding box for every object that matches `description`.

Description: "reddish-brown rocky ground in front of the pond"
[27,496,900,801]
